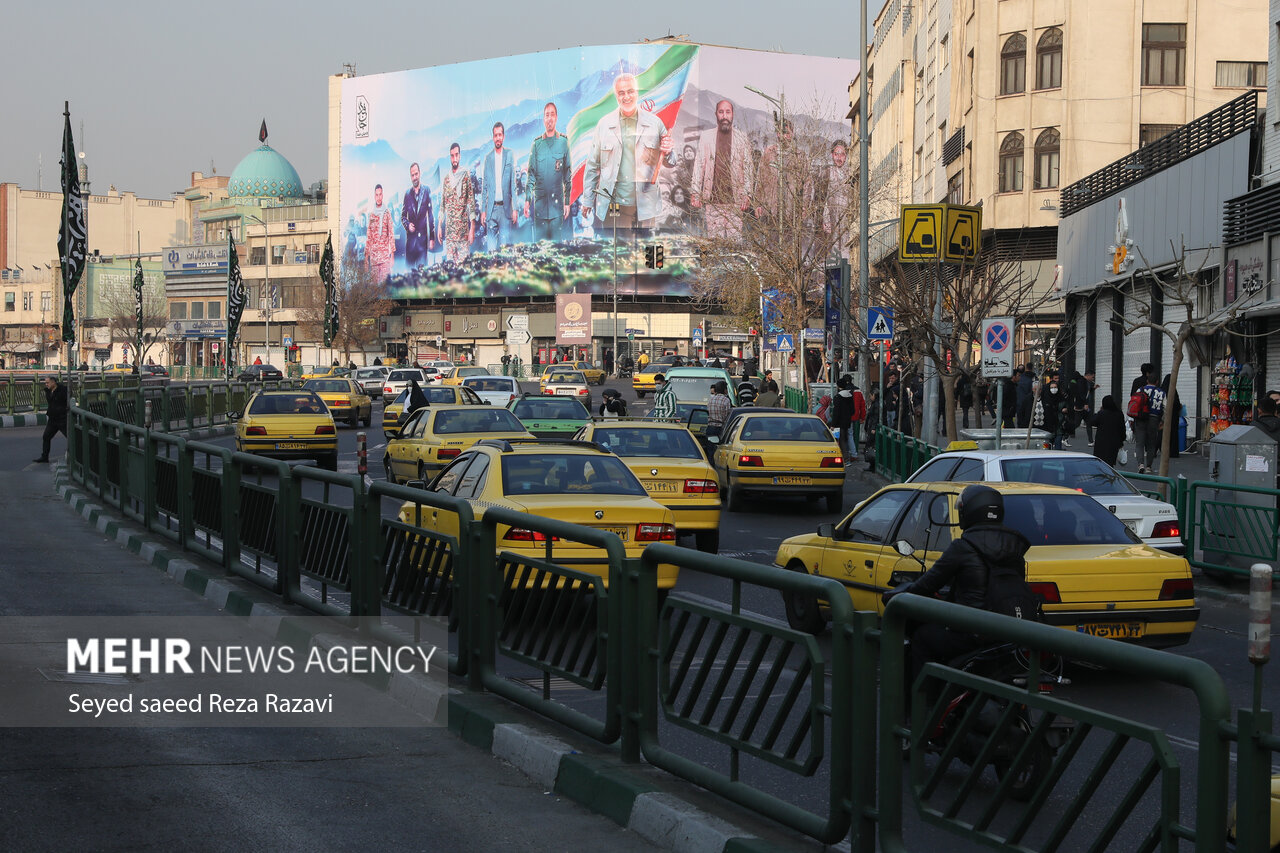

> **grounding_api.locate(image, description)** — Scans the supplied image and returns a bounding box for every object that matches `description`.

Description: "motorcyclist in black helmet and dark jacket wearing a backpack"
[882,483,1039,706]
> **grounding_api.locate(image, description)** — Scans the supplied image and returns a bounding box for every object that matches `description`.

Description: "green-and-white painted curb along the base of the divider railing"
[52,466,819,853]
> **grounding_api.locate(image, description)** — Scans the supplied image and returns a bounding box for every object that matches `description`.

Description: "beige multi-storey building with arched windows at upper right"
[855,0,1274,356]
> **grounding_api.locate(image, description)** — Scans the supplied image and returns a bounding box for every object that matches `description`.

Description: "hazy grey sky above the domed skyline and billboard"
[0,0,883,197]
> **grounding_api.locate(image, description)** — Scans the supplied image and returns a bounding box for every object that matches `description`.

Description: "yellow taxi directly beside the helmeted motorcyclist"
[773,482,1199,648]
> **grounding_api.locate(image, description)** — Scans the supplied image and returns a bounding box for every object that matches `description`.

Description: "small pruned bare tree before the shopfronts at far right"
[1111,243,1266,476]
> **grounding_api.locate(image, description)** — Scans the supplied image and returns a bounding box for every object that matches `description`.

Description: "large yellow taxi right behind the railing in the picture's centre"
[399,439,678,590]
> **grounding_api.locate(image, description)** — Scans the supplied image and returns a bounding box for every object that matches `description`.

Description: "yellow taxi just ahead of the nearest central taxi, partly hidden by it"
[575,419,721,553]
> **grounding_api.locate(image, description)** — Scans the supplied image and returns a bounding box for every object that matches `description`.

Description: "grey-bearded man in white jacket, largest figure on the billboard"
[582,74,676,228]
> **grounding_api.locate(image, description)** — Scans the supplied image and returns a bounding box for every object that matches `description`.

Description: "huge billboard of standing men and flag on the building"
[339,42,858,298]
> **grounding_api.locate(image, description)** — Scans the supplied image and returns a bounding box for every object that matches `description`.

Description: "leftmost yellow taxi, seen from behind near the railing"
[229,388,338,471]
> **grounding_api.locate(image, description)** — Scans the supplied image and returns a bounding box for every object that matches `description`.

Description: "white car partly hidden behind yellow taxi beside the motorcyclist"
[906,450,1185,555]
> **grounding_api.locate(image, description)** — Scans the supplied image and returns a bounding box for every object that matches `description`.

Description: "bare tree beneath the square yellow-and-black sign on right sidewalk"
[872,234,1050,441]
